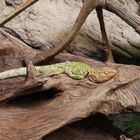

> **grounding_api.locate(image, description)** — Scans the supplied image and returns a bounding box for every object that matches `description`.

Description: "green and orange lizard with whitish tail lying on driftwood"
[0,61,117,83]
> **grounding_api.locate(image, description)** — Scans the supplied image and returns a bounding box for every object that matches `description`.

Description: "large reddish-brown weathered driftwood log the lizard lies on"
[0,30,140,140]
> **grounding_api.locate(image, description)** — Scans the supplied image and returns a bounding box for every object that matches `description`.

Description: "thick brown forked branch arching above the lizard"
[36,0,140,61]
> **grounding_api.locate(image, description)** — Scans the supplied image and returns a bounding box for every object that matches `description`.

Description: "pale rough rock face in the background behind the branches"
[0,0,140,62]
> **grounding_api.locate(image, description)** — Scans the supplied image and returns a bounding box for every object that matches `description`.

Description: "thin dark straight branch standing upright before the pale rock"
[96,7,114,62]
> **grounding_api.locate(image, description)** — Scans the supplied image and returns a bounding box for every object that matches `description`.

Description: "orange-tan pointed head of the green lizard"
[88,67,118,83]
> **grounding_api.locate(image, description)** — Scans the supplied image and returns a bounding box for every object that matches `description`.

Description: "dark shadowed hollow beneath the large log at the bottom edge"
[43,115,117,140]
